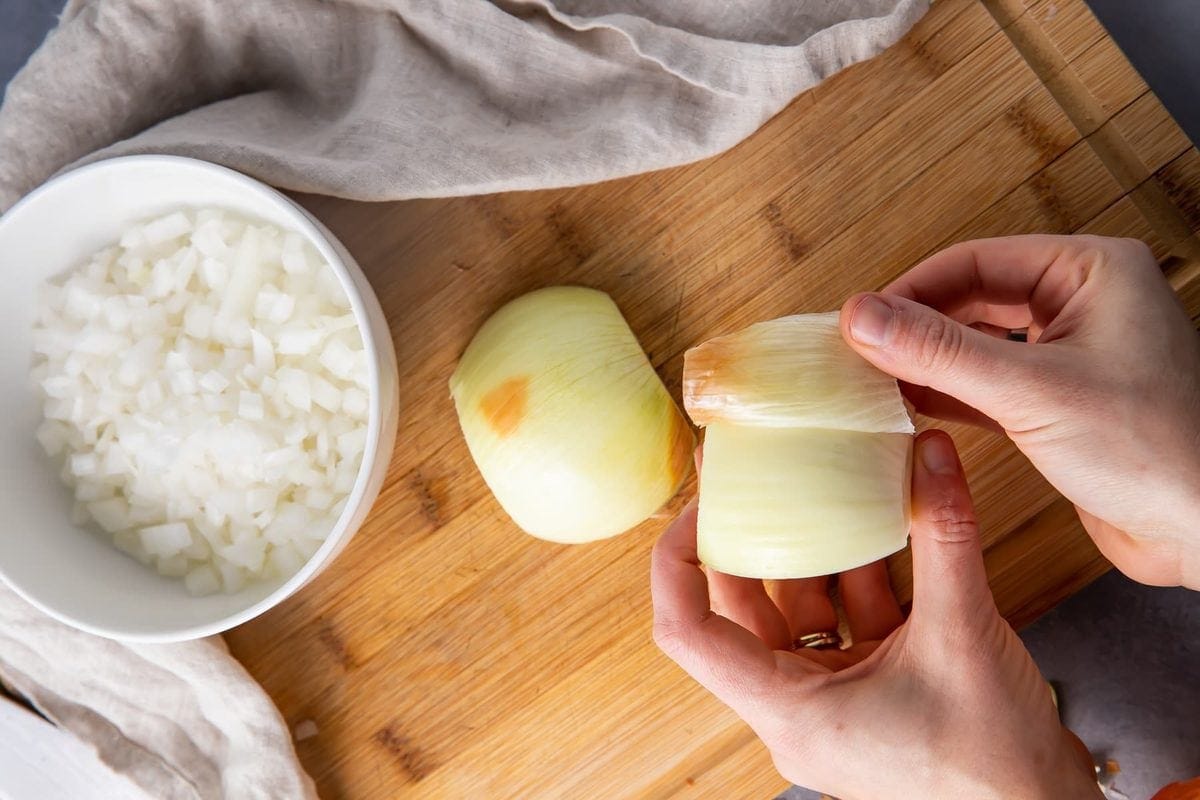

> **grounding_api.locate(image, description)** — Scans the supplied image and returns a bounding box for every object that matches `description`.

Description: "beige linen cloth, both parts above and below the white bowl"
[0,0,929,799]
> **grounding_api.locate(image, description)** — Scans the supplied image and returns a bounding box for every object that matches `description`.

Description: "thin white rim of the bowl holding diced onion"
[0,154,395,644]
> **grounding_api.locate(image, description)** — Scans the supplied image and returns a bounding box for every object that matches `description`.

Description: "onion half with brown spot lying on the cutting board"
[450,287,696,543]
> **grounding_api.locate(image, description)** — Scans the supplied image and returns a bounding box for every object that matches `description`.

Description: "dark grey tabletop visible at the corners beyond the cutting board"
[0,0,1200,800]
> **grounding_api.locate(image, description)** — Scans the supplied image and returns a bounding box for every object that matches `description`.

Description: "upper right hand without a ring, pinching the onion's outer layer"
[841,236,1200,589]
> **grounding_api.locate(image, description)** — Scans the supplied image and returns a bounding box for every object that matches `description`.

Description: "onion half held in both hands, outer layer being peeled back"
[683,312,913,578]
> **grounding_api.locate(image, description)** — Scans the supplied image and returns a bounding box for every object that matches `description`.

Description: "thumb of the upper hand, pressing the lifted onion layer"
[841,294,1040,427]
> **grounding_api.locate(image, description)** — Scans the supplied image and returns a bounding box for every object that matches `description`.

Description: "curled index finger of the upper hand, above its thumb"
[886,236,1104,327]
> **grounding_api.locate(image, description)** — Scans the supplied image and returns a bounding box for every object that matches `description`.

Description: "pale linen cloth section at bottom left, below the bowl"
[0,585,317,800]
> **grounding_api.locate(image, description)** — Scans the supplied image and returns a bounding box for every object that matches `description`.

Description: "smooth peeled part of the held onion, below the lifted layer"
[697,423,912,578]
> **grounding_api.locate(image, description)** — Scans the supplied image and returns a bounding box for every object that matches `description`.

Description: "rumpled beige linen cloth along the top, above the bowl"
[0,0,928,209]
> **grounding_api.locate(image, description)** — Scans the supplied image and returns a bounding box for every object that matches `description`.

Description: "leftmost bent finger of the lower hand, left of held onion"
[650,501,775,710]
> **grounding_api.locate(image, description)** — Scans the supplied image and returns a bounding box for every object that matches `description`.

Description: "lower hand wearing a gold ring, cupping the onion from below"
[652,431,1100,800]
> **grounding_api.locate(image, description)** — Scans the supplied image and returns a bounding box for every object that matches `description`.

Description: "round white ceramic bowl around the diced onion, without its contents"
[0,156,397,642]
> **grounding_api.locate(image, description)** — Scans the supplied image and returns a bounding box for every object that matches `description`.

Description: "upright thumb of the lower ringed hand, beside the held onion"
[911,431,996,626]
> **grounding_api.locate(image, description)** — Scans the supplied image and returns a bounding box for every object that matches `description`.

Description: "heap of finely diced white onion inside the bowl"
[31,210,370,595]
